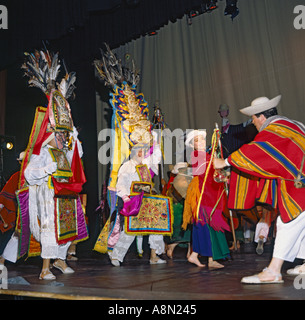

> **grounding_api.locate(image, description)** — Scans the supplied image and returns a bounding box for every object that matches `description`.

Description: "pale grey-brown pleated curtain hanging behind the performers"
[97,0,305,190]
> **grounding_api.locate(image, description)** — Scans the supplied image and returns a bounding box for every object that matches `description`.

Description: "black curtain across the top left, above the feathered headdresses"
[0,0,202,70]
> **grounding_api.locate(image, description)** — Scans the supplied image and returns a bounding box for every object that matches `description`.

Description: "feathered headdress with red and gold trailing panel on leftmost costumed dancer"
[19,50,76,187]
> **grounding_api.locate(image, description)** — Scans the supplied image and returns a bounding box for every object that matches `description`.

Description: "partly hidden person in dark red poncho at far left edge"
[0,151,25,264]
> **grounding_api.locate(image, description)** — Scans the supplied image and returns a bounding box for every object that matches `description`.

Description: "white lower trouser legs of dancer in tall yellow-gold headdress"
[110,230,165,262]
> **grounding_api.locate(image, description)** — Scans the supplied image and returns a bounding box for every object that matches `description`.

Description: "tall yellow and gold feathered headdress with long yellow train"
[94,44,153,189]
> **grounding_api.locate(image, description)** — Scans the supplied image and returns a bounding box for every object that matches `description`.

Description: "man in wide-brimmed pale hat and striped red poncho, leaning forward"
[214,96,305,284]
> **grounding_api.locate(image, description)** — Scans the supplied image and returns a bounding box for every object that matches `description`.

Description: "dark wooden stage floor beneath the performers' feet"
[0,244,305,301]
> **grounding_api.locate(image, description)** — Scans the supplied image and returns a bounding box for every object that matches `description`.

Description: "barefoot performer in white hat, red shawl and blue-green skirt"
[182,130,230,268]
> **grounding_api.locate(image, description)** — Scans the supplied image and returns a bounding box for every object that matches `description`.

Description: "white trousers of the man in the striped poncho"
[273,211,305,262]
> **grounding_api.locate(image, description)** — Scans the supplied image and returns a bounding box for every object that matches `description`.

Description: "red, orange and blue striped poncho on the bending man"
[228,116,305,223]
